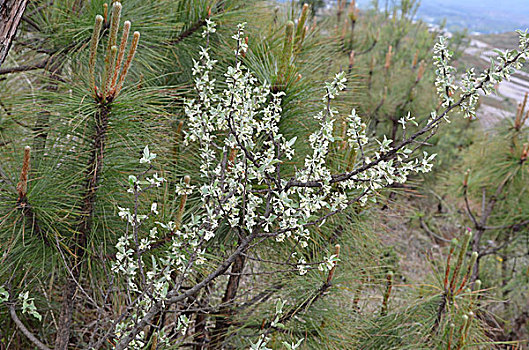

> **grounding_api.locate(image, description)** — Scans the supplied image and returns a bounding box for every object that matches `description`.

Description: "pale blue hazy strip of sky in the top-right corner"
[357,0,529,33]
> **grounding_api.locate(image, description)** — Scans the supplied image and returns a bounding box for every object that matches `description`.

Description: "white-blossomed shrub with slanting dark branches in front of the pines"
[102,22,527,348]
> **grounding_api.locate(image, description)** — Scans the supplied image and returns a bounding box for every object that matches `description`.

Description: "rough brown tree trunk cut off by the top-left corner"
[0,0,28,66]
